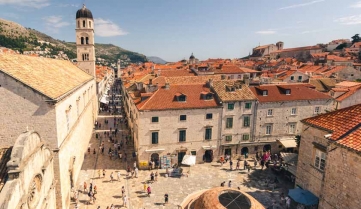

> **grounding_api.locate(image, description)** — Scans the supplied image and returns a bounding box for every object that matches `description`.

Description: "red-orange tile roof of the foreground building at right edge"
[302,104,361,151]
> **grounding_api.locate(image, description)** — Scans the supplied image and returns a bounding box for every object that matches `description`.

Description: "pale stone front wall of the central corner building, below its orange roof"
[134,108,221,166]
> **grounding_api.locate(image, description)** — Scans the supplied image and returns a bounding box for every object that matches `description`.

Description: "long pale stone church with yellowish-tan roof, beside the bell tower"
[0,54,98,208]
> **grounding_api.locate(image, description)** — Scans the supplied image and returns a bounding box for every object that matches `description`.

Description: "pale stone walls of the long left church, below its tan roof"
[0,73,98,208]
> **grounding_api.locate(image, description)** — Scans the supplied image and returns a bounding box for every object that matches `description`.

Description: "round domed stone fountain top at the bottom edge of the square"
[181,187,265,209]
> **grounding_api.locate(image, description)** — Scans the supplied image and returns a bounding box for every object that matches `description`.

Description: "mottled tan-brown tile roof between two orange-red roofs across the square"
[213,80,257,102]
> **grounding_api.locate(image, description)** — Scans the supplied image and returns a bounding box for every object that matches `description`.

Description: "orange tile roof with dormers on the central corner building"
[137,84,218,110]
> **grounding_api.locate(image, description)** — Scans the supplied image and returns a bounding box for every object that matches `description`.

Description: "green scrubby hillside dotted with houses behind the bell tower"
[0,19,147,65]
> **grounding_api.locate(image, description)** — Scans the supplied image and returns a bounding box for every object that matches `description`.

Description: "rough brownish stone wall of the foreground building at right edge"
[296,125,361,209]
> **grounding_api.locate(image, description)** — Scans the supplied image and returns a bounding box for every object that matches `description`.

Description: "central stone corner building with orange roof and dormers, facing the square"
[126,83,221,168]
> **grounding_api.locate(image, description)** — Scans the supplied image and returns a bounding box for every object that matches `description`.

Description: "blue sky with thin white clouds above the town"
[0,0,361,61]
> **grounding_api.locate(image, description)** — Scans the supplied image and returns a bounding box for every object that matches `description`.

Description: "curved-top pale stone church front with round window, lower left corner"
[0,131,56,209]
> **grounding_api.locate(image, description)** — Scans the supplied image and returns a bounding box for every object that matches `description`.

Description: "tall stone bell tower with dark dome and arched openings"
[75,5,95,77]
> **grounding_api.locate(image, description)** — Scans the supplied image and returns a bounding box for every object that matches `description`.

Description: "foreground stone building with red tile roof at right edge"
[296,104,361,209]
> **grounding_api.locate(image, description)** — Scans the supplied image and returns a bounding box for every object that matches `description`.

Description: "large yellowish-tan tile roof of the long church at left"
[0,54,93,99]
